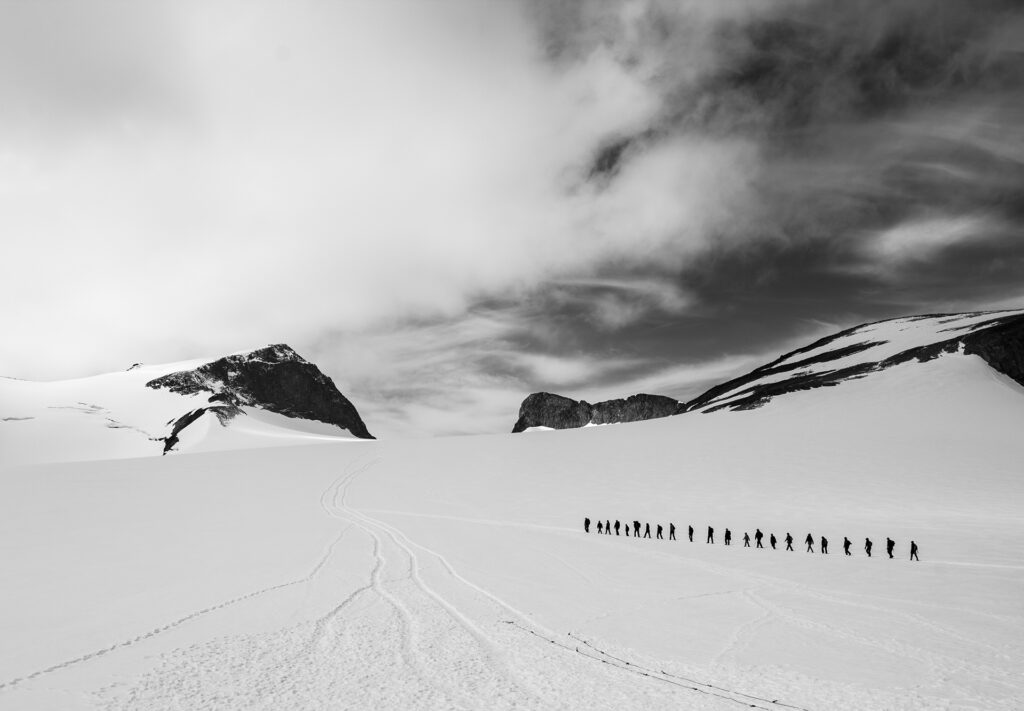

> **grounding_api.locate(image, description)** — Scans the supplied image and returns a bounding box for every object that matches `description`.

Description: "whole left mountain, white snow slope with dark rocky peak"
[0,345,372,467]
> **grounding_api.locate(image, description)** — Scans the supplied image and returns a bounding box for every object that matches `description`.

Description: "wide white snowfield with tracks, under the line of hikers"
[0,353,1024,711]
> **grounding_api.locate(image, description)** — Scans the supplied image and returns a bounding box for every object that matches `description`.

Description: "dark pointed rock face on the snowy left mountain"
[146,344,374,442]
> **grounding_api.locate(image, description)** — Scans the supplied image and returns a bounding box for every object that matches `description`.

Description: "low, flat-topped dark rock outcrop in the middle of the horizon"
[512,392,680,432]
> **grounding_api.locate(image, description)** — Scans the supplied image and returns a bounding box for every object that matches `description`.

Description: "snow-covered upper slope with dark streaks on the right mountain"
[700,309,1024,411]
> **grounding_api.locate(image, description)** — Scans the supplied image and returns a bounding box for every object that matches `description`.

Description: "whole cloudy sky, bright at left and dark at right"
[0,0,1024,436]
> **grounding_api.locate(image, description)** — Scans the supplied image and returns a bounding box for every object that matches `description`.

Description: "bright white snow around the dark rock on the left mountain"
[0,351,355,467]
